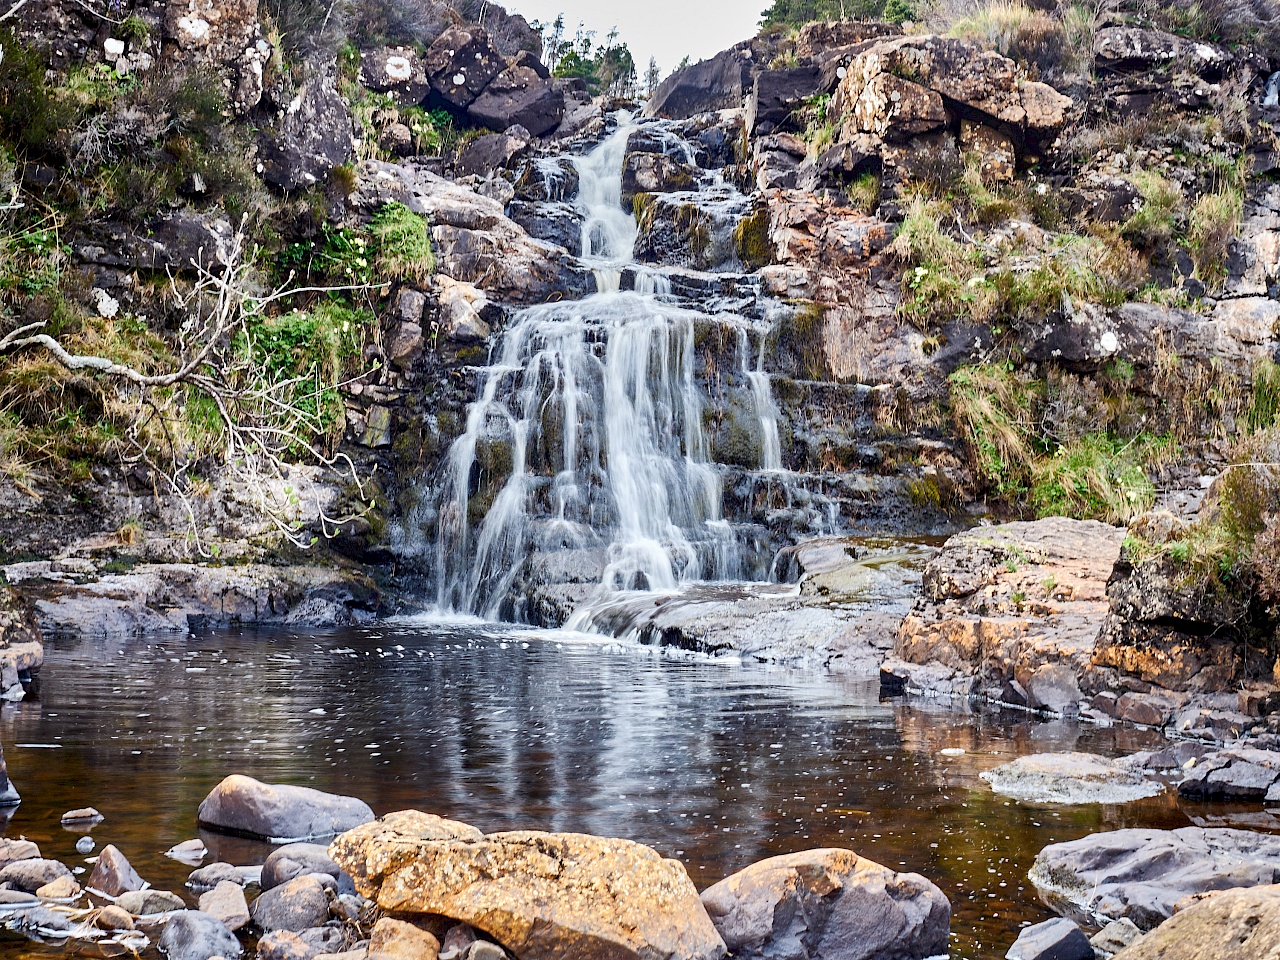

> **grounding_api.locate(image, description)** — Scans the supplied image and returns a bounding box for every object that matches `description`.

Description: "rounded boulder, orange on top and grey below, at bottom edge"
[703,849,951,960]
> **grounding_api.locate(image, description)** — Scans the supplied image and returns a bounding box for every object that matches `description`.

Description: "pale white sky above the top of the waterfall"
[503,0,769,79]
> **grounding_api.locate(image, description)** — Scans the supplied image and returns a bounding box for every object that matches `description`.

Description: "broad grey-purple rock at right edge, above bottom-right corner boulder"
[1028,827,1280,929]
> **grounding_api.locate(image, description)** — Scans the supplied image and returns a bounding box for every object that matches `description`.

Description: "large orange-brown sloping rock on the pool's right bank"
[884,517,1125,713]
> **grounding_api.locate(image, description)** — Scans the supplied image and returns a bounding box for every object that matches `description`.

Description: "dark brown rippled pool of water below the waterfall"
[0,621,1218,959]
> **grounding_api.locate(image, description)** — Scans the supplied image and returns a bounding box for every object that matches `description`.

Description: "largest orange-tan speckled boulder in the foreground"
[329,810,724,960]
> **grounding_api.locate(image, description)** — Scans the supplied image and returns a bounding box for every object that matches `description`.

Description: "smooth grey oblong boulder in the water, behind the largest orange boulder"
[197,774,374,844]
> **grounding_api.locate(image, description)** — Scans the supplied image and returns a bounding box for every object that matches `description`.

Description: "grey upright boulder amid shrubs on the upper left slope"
[259,72,353,191]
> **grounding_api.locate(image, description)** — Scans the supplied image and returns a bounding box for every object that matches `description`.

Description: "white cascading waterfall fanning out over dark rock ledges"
[436,116,782,617]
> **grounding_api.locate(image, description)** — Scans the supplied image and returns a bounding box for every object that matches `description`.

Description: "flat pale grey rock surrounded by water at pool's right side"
[982,753,1165,804]
